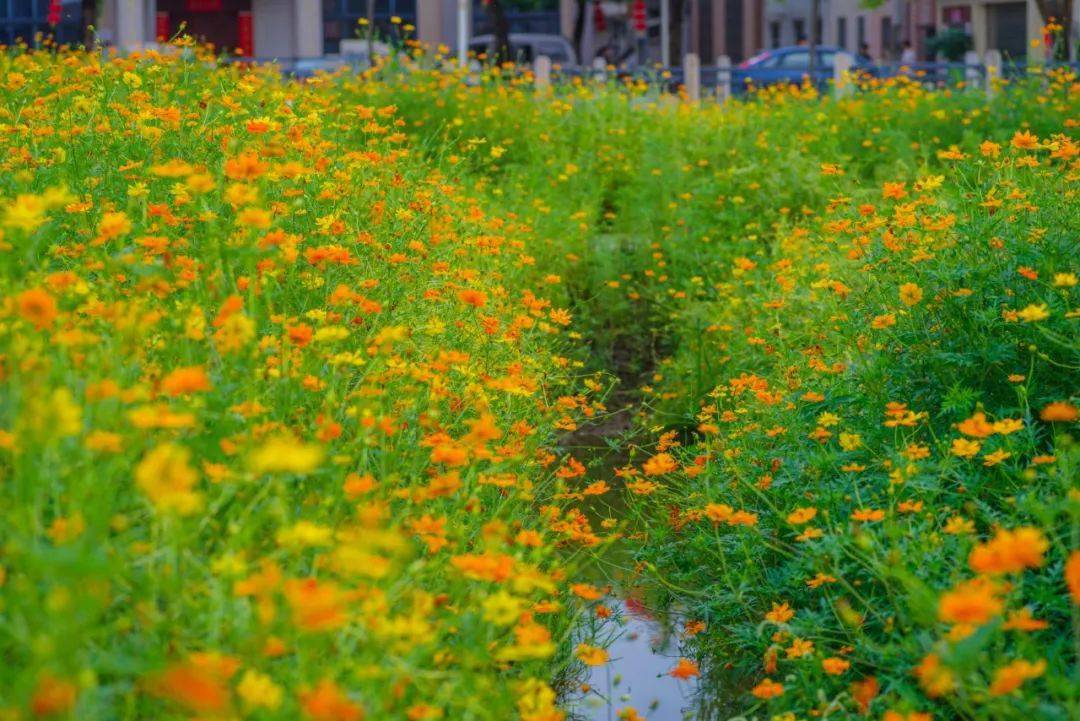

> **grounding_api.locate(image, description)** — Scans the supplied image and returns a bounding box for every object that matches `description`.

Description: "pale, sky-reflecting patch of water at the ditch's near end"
[571,599,698,721]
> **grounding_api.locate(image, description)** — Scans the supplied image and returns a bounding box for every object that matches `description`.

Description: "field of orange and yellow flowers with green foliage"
[0,43,1080,721]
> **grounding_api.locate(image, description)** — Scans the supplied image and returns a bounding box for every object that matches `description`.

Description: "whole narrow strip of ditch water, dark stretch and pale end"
[563,411,699,721]
